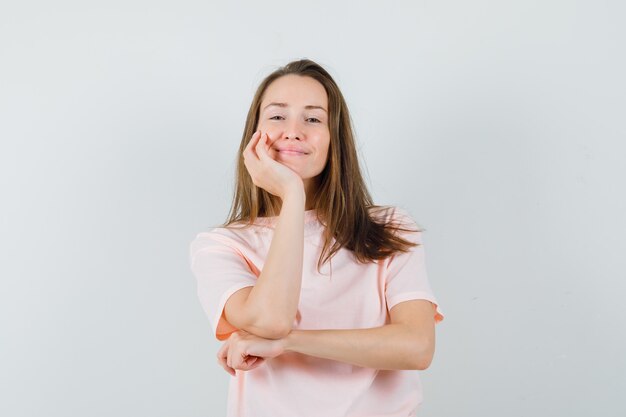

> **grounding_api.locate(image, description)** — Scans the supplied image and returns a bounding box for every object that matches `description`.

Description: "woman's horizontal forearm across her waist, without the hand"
[282,324,433,369]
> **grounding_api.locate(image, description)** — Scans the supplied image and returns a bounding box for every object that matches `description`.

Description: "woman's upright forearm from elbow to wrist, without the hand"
[246,187,306,337]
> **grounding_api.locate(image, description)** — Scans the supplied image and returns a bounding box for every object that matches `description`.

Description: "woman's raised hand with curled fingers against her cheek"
[243,130,304,200]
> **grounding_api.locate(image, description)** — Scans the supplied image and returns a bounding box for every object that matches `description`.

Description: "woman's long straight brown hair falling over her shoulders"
[222,59,423,270]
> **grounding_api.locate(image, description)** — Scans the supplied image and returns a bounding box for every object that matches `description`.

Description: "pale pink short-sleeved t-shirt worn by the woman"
[190,207,444,417]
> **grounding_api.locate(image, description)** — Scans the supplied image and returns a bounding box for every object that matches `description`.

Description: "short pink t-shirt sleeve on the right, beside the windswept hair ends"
[385,211,444,323]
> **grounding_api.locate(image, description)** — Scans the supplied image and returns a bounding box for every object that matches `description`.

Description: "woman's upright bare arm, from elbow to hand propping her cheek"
[225,132,306,339]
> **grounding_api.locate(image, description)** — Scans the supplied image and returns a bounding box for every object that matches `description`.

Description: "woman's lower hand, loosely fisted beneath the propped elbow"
[217,330,285,376]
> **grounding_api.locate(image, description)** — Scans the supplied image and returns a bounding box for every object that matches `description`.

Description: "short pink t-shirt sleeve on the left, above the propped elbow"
[189,232,257,340]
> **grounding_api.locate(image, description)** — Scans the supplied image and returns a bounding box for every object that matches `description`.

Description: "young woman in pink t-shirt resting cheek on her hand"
[190,59,443,417]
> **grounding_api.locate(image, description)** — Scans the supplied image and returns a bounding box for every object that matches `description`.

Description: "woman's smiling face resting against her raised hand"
[257,74,330,189]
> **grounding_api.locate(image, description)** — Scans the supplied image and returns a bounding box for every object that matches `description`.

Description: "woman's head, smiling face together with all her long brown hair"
[224,59,420,266]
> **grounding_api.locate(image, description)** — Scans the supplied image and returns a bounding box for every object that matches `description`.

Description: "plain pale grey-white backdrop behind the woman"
[0,0,626,417]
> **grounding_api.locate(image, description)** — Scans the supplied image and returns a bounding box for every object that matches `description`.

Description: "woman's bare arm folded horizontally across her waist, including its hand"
[222,300,435,374]
